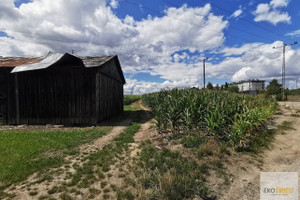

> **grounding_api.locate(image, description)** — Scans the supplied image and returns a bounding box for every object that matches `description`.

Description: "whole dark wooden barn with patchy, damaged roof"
[0,53,125,125]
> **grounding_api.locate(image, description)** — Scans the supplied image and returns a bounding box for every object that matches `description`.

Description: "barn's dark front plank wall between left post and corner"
[14,66,97,125]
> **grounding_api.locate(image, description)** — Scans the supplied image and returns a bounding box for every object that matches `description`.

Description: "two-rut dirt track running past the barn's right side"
[4,101,155,200]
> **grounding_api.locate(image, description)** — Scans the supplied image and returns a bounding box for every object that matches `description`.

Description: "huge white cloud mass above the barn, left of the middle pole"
[0,0,228,93]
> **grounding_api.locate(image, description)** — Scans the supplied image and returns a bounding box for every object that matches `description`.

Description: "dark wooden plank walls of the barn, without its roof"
[0,60,123,125]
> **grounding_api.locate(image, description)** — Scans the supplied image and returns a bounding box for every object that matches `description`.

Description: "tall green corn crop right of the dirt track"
[142,89,277,145]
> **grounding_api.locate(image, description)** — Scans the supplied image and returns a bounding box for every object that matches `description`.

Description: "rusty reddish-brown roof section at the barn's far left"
[0,57,44,67]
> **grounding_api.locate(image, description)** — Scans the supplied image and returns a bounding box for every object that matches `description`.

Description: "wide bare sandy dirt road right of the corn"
[220,102,300,200]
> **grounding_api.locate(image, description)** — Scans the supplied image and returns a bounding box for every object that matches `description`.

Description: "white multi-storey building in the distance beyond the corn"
[237,79,265,95]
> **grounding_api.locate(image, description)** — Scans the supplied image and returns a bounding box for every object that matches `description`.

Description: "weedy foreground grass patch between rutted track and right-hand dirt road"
[137,144,209,200]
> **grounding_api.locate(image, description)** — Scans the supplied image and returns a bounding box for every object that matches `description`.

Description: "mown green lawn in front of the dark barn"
[0,127,110,187]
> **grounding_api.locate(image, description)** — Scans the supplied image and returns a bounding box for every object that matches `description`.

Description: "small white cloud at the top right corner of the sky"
[253,0,291,25]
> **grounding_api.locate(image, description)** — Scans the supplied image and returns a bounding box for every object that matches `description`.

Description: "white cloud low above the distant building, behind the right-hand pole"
[227,41,300,81]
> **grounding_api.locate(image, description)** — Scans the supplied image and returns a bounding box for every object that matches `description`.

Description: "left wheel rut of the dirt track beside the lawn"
[5,119,132,200]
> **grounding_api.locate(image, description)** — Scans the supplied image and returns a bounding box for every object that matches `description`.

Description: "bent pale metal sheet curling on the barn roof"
[11,53,65,73]
